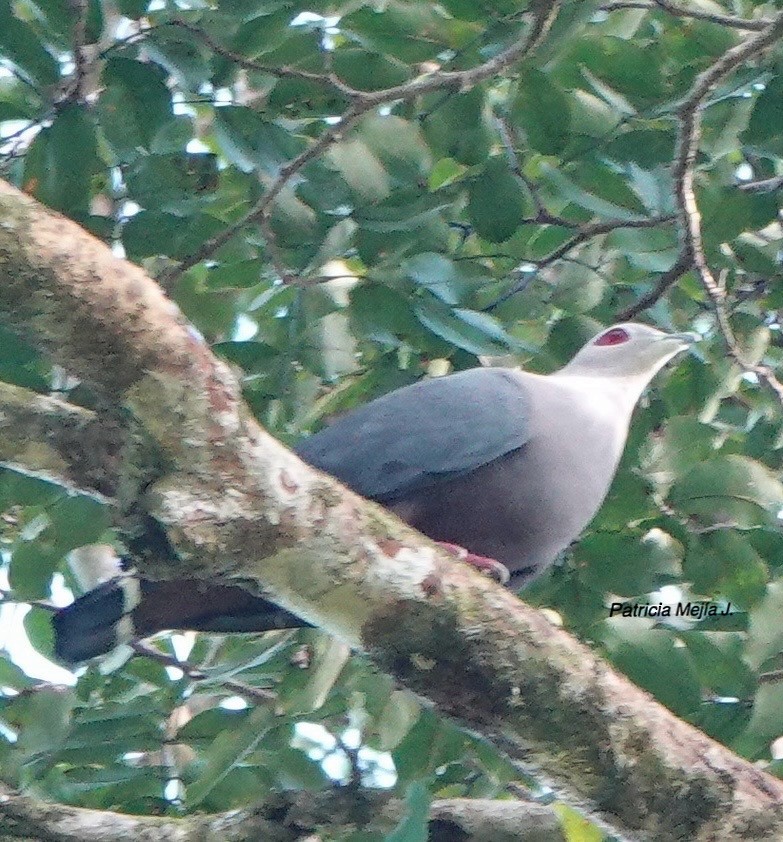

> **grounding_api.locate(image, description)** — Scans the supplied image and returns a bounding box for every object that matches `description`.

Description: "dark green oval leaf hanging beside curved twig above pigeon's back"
[468,156,532,243]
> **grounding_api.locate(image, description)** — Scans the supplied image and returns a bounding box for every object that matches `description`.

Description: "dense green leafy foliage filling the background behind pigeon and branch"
[0,0,783,839]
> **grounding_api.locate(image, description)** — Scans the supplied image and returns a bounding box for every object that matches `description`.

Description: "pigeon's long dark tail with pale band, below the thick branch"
[52,575,308,664]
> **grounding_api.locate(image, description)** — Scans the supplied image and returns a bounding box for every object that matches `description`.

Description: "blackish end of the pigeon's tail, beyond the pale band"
[52,577,133,664]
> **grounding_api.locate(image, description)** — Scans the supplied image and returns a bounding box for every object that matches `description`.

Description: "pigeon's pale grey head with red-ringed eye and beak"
[561,322,699,385]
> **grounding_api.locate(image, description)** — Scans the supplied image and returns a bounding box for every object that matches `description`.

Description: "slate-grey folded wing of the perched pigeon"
[295,368,530,501]
